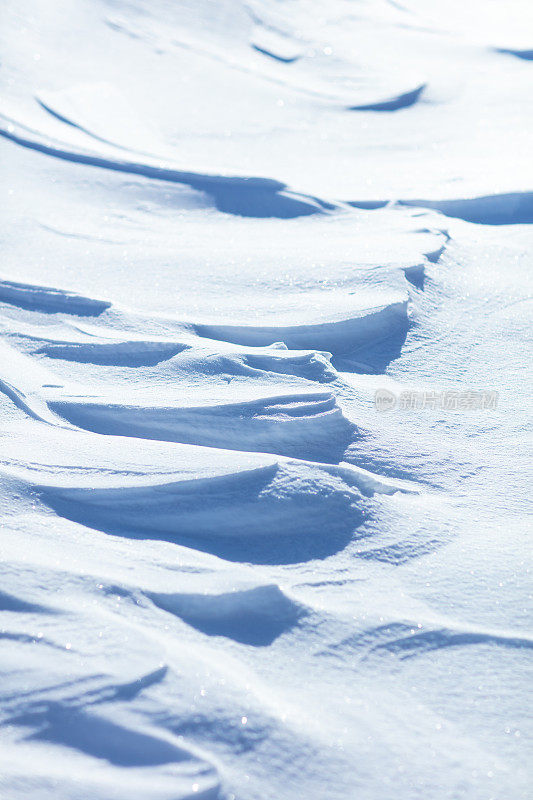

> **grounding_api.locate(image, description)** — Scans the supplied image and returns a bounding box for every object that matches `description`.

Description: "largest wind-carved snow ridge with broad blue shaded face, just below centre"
[2,410,410,563]
